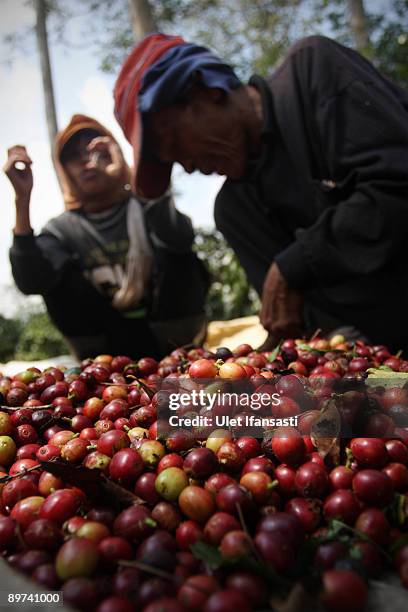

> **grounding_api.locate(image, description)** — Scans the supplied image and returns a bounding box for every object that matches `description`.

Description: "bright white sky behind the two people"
[0,0,223,312]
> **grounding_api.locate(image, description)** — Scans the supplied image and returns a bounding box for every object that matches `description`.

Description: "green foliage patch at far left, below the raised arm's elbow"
[14,313,69,361]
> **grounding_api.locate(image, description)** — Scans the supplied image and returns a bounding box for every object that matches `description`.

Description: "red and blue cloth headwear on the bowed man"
[114,34,241,198]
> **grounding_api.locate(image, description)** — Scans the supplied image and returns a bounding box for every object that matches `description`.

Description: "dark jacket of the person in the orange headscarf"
[10,198,208,356]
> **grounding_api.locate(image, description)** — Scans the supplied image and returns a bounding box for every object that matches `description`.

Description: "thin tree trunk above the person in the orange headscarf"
[35,0,58,159]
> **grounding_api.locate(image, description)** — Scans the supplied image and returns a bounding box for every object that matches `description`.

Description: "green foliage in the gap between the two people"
[195,229,259,320]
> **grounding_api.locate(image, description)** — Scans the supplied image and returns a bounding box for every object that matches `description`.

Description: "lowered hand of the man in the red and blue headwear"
[260,263,303,343]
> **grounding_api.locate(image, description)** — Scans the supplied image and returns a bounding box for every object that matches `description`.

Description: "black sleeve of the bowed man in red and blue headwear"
[276,39,408,288]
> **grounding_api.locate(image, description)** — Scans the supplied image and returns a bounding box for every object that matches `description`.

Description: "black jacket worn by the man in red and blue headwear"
[218,36,408,314]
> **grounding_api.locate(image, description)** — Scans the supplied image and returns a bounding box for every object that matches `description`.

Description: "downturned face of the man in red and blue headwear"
[147,88,248,179]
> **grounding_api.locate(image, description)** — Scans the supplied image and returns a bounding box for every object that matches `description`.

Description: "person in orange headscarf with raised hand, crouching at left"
[4,115,207,359]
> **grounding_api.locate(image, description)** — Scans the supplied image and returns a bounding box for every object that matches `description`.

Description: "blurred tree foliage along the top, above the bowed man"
[77,0,408,85]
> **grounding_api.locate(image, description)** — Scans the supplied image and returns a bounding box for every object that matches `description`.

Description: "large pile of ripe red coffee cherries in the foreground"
[0,336,408,612]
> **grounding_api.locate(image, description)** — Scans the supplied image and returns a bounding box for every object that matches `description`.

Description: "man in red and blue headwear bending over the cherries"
[114,34,408,349]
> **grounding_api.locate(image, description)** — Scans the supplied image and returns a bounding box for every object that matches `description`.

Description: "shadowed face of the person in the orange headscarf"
[61,130,116,197]
